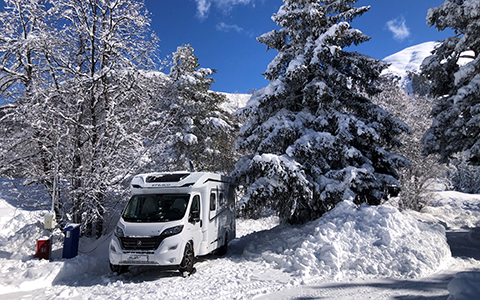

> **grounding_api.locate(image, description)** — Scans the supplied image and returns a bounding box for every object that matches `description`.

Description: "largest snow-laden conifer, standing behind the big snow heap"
[233,0,409,223]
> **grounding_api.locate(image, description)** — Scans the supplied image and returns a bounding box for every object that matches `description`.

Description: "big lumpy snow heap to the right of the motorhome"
[243,201,451,280]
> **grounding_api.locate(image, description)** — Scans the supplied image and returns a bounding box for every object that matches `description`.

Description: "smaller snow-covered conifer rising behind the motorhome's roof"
[158,45,238,173]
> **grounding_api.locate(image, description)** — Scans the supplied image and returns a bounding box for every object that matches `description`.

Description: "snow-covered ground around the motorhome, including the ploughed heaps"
[0,179,480,300]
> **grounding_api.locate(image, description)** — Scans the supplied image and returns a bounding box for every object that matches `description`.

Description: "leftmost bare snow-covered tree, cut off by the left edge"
[0,0,66,215]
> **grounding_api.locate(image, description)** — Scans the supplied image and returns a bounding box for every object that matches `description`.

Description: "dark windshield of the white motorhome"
[122,194,190,222]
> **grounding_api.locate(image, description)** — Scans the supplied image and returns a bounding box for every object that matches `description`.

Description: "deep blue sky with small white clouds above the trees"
[145,0,452,93]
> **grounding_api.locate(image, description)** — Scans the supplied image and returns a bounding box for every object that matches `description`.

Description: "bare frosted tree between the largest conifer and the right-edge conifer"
[372,73,447,211]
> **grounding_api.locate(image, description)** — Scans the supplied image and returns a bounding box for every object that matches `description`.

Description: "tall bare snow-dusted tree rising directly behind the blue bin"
[52,0,157,234]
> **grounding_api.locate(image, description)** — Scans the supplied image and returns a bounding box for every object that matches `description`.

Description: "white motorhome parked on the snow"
[109,172,235,276]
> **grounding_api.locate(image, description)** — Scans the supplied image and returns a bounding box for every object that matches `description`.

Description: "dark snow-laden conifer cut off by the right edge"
[422,0,480,165]
